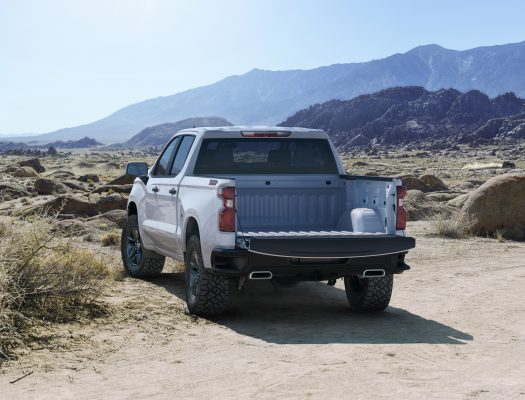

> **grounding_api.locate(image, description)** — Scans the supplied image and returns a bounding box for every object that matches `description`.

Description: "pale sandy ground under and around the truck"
[0,222,525,399]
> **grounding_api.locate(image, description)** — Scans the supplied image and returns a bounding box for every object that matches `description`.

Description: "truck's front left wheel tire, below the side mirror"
[120,214,165,278]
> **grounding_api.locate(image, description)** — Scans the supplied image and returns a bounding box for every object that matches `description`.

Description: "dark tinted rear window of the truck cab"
[193,138,338,175]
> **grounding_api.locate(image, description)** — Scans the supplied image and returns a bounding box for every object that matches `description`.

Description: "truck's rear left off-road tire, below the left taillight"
[184,235,230,315]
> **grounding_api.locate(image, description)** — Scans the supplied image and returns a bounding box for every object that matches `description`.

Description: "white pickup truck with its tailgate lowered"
[121,127,415,315]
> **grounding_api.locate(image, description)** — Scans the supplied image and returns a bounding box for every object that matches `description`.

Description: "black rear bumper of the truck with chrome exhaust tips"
[211,249,410,280]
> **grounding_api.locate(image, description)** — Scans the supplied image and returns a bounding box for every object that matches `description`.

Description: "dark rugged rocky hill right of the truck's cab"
[280,86,525,147]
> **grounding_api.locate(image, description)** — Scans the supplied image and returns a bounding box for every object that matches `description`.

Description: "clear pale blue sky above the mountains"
[0,0,525,134]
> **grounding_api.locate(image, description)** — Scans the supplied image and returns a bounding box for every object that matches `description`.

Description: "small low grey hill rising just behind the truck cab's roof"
[122,117,232,147]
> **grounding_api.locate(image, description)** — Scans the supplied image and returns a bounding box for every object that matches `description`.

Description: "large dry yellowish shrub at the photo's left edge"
[0,218,112,358]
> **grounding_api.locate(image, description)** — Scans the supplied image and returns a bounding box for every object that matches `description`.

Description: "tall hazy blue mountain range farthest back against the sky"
[5,42,525,143]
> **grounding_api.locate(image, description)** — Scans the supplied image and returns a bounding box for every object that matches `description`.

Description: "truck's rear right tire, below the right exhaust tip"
[344,274,394,312]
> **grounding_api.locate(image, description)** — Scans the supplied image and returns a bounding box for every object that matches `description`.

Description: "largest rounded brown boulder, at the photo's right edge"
[460,174,525,235]
